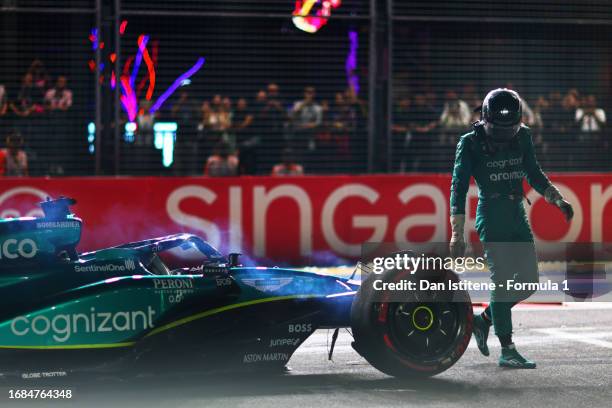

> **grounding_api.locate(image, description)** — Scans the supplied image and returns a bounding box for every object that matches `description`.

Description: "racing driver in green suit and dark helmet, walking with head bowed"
[450,88,573,368]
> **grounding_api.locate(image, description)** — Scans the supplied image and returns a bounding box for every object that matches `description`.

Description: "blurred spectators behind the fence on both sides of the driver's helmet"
[392,84,612,172]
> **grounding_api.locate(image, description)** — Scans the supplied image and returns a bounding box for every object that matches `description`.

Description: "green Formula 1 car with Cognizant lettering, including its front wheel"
[0,197,472,378]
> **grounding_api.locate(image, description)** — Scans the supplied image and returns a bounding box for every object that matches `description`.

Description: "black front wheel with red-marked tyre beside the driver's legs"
[351,260,473,378]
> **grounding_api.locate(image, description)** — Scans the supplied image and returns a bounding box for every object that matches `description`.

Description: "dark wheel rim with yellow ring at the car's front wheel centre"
[389,302,461,361]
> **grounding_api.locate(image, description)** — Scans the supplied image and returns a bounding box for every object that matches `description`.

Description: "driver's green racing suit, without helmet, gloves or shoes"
[450,123,551,336]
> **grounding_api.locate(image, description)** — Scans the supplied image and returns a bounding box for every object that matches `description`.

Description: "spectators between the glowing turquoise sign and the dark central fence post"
[165,83,366,175]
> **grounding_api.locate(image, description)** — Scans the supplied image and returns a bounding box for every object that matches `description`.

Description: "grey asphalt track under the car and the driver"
[0,304,612,408]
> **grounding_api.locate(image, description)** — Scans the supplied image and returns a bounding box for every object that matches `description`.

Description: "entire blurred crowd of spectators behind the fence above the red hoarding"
[0,60,611,176]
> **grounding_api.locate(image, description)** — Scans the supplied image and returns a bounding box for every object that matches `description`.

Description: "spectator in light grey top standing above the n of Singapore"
[290,86,323,155]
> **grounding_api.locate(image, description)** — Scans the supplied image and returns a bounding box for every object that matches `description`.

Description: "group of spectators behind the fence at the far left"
[0,59,74,176]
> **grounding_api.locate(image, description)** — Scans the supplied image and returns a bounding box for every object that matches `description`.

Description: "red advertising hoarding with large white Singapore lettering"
[0,174,612,261]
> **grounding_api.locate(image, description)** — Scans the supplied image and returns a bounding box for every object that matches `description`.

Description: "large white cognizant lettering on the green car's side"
[11,306,157,343]
